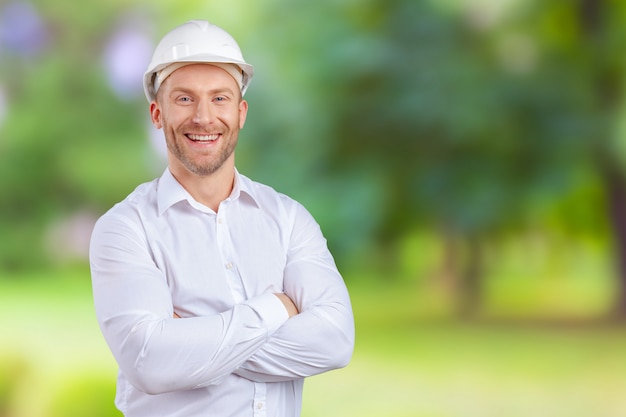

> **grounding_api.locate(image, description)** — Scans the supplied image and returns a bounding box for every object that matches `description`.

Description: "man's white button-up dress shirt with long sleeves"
[90,170,354,417]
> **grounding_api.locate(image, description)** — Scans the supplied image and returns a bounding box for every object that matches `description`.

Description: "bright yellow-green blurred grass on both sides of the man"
[0,267,626,417]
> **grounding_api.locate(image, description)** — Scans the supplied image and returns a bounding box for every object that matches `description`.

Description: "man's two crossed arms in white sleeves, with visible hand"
[91,208,354,394]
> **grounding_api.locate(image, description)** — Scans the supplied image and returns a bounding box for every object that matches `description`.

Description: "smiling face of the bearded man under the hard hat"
[150,64,248,176]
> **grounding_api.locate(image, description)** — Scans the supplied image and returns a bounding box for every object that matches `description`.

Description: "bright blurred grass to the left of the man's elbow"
[0,268,120,417]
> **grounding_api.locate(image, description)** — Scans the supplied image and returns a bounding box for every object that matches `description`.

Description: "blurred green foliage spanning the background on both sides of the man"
[0,0,626,316]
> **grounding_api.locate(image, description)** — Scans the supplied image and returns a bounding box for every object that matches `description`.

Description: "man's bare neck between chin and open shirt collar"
[170,164,235,213]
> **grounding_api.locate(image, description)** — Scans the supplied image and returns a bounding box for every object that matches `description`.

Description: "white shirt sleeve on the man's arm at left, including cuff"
[90,214,288,394]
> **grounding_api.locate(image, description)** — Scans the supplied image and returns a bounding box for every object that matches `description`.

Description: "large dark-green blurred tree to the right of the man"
[247,0,606,314]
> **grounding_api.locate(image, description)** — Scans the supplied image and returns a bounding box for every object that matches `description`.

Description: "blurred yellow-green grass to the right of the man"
[304,282,626,417]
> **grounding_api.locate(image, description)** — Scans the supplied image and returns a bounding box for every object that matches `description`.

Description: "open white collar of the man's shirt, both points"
[157,168,259,216]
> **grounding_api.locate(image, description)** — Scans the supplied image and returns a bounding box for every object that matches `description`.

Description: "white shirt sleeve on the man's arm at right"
[235,204,355,382]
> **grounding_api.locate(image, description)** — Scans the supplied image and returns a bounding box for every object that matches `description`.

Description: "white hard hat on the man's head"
[143,20,254,101]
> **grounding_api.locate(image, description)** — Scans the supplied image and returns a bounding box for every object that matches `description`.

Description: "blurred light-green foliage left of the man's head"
[0,3,156,269]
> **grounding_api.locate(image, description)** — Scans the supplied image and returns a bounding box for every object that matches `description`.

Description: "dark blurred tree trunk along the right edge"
[568,0,626,320]
